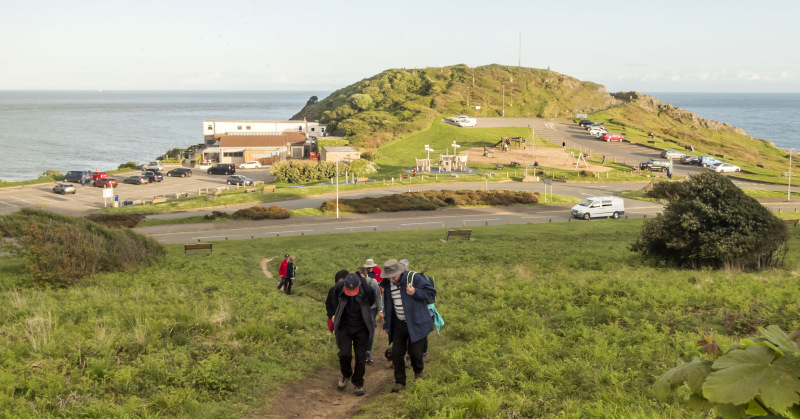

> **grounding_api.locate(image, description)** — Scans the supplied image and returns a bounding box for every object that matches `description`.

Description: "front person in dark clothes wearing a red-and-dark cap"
[333,273,377,396]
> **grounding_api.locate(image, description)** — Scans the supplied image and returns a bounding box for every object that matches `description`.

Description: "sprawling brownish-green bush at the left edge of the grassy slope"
[0,208,165,286]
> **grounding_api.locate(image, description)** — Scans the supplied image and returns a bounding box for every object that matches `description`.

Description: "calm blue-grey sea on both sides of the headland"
[0,90,800,181]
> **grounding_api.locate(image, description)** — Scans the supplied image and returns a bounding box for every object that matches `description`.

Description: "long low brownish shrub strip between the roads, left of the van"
[320,190,539,213]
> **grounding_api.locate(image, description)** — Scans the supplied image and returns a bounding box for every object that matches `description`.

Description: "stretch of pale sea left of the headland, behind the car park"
[0,91,330,181]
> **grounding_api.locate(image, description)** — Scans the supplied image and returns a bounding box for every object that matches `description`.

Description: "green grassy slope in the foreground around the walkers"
[0,220,800,417]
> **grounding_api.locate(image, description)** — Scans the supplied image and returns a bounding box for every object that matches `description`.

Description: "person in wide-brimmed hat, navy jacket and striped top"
[381,259,436,393]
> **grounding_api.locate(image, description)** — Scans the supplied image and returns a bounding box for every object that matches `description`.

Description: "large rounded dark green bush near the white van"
[631,172,789,269]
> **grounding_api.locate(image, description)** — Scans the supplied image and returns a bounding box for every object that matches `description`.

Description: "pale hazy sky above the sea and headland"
[0,0,800,92]
